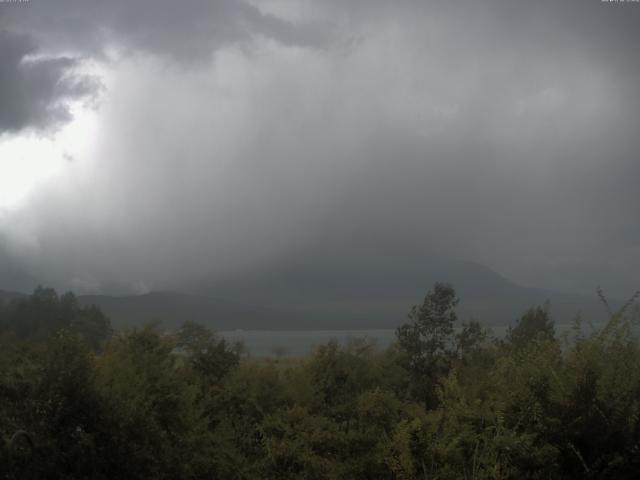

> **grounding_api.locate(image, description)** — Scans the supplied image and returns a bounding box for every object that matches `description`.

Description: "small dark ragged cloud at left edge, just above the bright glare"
[0,29,97,134]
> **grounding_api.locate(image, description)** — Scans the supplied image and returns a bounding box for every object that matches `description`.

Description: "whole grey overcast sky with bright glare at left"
[0,0,640,296]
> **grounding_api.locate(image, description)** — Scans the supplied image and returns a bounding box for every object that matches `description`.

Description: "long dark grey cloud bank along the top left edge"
[5,0,326,62]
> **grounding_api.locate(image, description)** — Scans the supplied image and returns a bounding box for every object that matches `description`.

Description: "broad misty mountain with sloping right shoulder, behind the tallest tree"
[191,259,621,329]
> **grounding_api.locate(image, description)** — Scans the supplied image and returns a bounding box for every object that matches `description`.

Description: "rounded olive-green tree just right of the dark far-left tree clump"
[95,325,199,479]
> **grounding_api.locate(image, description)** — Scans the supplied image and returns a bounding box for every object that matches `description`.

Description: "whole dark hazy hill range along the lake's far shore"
[0,260,621,330]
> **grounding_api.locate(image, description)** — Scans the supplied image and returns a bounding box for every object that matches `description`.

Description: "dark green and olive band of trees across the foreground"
[0,284,640,480]
